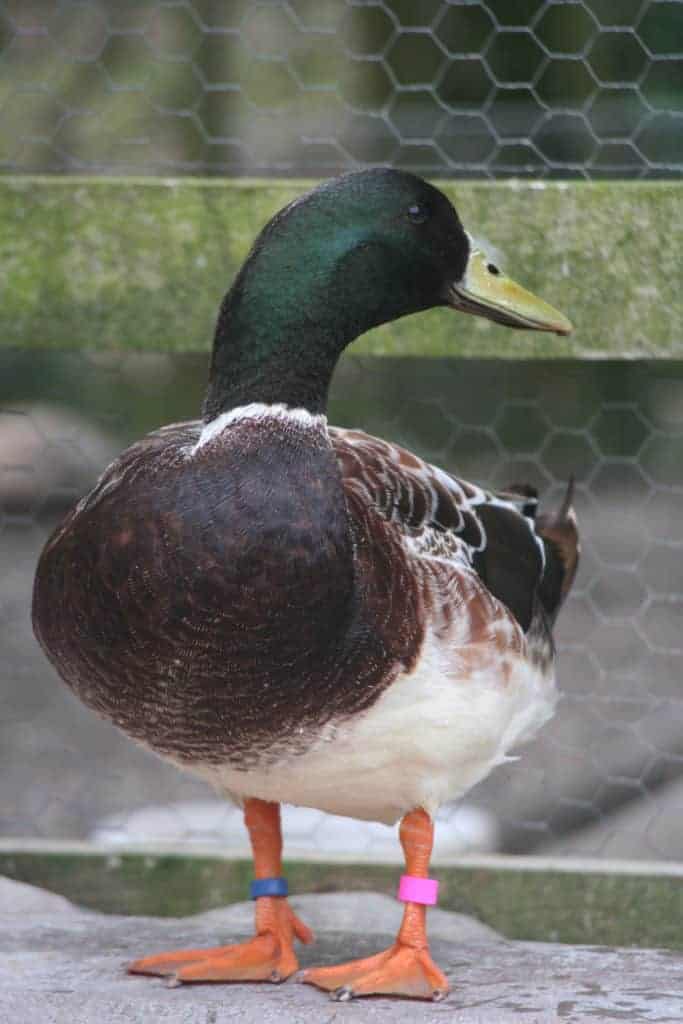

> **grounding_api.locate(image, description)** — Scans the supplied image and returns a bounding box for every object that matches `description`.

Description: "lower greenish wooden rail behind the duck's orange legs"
[0,840,683,949]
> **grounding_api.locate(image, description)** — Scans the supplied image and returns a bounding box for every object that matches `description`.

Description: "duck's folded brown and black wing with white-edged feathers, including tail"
[330,428,578,630]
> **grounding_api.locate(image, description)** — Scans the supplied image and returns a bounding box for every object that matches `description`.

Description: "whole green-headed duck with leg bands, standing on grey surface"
[33,168,579,1000]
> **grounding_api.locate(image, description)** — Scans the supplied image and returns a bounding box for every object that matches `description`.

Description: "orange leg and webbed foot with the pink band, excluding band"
[300,809,449,1000]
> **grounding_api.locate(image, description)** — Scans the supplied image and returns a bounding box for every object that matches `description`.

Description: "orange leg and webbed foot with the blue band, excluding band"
[128,800,313,984]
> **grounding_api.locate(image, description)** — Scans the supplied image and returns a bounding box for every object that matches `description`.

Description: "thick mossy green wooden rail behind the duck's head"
[0,176,683,358]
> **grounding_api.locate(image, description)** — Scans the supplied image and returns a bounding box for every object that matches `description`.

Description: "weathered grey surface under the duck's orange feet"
[0,880,683,1024]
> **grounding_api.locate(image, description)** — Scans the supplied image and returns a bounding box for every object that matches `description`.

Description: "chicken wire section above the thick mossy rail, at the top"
[0,0,683,178]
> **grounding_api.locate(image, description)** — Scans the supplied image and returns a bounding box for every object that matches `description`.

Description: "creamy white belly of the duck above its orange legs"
[192,636,556,824]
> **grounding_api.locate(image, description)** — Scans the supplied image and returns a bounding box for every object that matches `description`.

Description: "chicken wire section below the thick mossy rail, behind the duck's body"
[0,351,683,859]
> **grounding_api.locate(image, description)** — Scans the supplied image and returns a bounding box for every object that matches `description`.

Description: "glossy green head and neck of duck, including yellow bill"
[205,168,571,419]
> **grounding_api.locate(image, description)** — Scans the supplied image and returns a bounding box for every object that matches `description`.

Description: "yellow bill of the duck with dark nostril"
[449,248,573,334]
